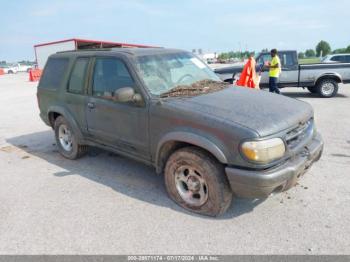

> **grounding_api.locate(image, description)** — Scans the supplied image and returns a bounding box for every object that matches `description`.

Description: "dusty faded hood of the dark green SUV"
[168,87,313,137]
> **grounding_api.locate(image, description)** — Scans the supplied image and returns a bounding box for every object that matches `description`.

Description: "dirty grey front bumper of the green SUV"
[225,134,323,198]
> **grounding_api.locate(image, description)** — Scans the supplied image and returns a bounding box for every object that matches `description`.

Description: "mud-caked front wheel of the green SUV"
[164,147,232,216]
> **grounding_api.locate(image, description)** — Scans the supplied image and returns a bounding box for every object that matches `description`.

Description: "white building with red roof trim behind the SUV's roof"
[34,38,155,69]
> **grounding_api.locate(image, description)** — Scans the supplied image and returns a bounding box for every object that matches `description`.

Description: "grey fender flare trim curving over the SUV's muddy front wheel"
[155,131,228,172]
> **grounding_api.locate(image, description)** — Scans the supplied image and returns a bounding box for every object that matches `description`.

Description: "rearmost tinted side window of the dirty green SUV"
[39,58,69,89]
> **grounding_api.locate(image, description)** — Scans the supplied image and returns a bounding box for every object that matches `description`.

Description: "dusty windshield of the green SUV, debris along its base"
[136,52,222,96]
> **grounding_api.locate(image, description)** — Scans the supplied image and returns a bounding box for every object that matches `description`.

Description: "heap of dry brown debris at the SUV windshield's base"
[159,79,229,98]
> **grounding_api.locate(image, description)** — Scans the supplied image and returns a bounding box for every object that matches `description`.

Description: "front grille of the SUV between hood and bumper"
[285,119,313,149]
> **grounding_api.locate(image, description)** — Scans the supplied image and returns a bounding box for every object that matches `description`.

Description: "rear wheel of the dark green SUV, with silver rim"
[54,116,88,160]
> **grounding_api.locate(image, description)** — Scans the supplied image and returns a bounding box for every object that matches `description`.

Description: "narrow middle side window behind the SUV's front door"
[68,58,89,94]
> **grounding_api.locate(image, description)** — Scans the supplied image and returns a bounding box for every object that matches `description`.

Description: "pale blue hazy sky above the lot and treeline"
[0,0,350,61]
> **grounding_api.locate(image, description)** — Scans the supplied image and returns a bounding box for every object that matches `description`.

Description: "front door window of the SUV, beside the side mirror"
[92,58,134,99]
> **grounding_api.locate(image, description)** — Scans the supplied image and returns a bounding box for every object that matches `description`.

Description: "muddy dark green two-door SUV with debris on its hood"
[37,48,323,216]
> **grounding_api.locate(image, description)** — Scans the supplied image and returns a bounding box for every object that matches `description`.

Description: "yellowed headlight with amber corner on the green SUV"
[241,138,286,163]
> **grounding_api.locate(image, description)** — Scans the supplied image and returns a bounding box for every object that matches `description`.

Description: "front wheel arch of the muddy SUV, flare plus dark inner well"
[155,132,227,174]
